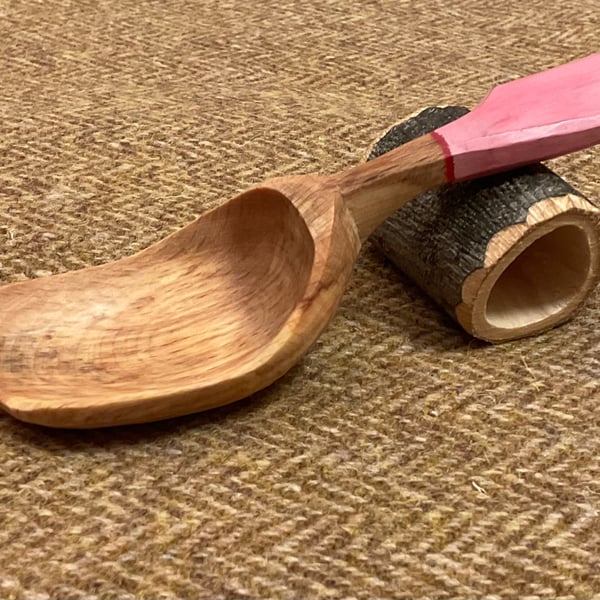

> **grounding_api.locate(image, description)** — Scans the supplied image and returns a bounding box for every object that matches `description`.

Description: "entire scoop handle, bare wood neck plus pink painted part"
[338,53,600,239]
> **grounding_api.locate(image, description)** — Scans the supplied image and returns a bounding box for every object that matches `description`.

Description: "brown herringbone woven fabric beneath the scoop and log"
[0,0,600,600]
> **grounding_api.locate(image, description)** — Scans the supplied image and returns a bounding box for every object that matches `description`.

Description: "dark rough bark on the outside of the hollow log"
[368,106,594,341]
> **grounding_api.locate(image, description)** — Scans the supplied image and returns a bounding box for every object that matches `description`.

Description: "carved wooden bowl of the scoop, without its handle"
[0,178,358,427]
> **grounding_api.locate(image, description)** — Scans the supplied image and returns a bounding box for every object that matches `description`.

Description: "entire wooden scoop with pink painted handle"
[0,54,600,427]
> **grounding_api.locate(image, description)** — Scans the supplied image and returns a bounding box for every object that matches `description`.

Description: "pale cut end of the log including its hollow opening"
[464,195,600,342]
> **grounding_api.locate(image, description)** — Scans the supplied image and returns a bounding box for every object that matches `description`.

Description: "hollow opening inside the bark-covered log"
[485,225,591,328]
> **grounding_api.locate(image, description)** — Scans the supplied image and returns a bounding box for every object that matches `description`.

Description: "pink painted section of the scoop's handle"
[433,53,600,182]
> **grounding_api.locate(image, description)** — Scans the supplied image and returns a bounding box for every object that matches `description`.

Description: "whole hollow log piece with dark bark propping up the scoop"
[368,106,600,342]
